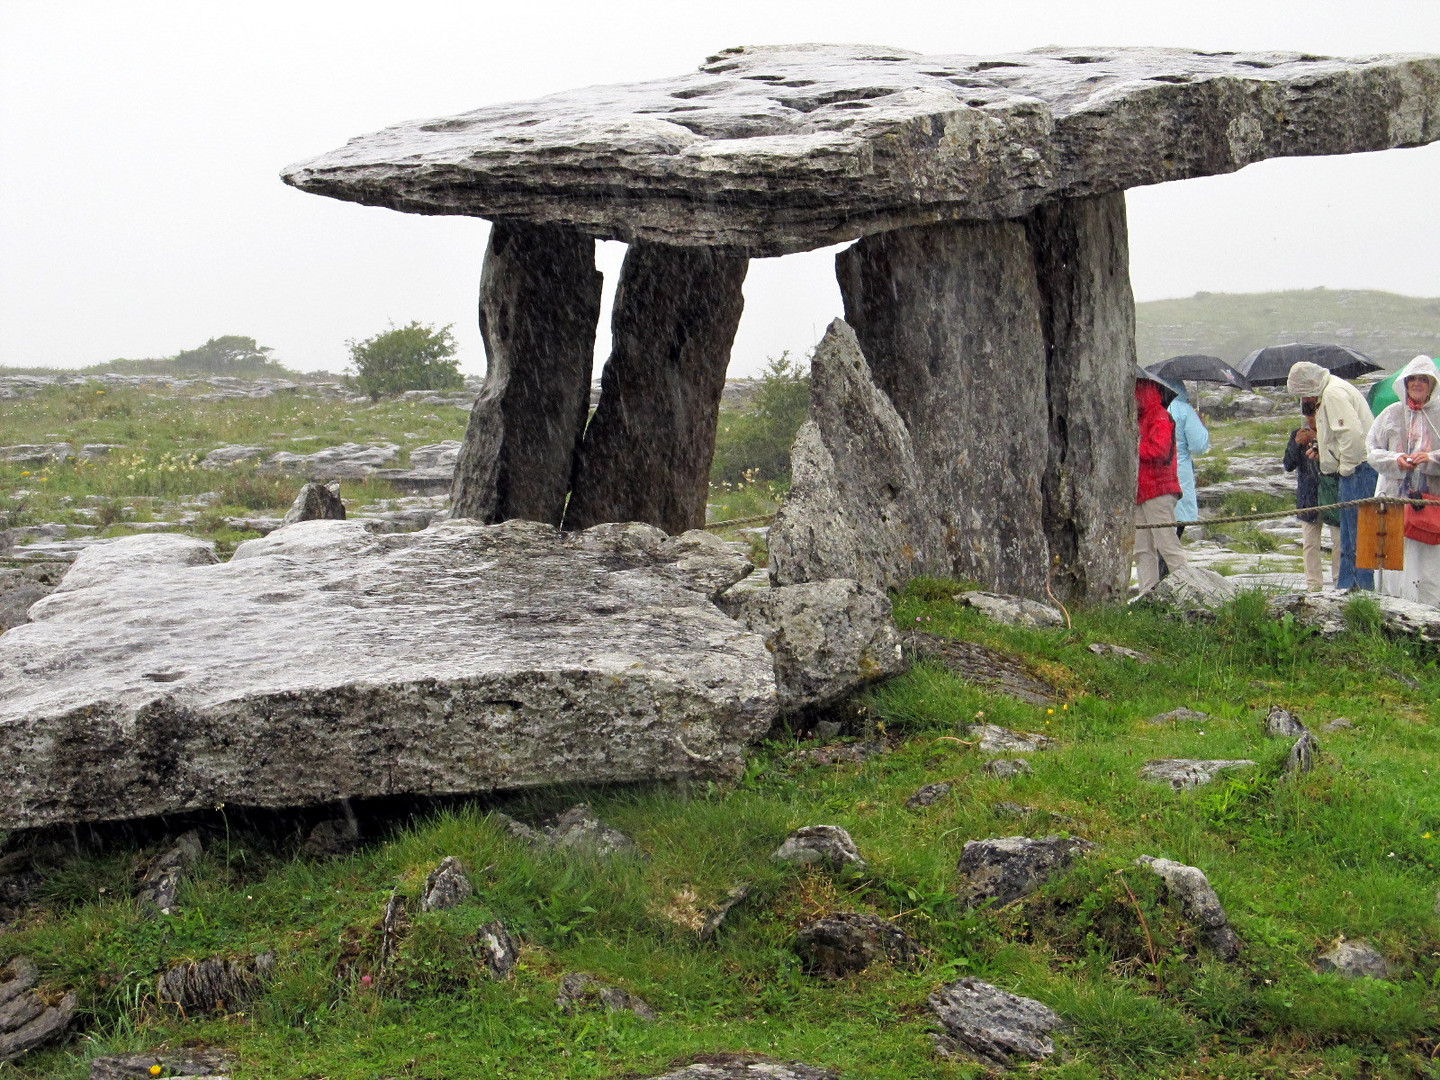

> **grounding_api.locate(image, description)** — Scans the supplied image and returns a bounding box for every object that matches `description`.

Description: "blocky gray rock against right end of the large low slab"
[720,580,904,713]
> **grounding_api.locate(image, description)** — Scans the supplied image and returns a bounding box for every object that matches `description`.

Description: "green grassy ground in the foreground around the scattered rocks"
[0,582,1440,1080]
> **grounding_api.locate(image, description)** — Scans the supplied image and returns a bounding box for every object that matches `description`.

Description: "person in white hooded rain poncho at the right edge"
[1367,356,1440,608]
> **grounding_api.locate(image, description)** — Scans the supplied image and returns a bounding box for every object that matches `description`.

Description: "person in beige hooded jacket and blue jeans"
[1286,360,1375,592]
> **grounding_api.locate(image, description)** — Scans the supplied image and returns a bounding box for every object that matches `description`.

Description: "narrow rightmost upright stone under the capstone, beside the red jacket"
[1027,192,1136,600]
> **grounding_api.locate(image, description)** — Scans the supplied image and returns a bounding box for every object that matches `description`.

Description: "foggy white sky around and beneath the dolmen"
[0,0,1440,374]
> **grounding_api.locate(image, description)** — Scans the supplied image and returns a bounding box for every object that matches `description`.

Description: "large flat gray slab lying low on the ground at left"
[0,520,776,828]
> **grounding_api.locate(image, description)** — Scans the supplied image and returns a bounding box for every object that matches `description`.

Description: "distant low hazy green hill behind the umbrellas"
[1135,288,1440,369]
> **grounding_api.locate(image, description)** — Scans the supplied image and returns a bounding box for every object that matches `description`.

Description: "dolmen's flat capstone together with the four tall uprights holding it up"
[282,45,1440,599]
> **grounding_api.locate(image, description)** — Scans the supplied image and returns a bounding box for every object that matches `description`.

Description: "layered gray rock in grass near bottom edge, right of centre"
[930,978,1066,1067]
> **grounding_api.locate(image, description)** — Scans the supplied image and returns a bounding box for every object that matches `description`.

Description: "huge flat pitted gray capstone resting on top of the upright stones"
[282,45,1440,255]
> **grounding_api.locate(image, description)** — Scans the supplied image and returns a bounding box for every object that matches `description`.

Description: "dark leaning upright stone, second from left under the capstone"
[564,240,749,533]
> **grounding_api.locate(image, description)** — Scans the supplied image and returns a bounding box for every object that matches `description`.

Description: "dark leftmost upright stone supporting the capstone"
[451,222,600,526]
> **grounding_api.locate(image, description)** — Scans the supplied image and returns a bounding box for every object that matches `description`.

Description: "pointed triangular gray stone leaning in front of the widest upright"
[766,318,949,589]
